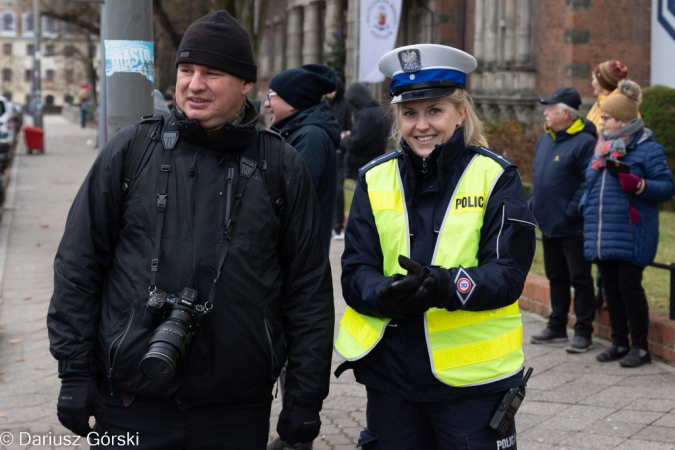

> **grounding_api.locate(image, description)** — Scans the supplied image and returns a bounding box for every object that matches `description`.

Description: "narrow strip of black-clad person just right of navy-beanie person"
[326,78,352,240]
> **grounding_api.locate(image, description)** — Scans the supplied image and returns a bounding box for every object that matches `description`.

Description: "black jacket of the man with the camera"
[47,104,334,410]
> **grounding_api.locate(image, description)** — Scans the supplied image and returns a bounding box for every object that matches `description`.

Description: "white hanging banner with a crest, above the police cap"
[358,0,402,83]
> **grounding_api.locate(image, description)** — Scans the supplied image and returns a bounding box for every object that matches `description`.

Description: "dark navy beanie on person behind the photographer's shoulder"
[270,64,337,109]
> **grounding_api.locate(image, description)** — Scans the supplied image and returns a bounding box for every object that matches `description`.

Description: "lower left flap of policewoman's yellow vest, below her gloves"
[335,307,389,361]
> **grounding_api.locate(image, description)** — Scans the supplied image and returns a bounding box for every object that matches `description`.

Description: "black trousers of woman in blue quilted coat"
[598,260,649,350]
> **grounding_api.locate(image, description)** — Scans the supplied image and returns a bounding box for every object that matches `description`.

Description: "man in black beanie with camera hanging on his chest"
[47,11,334,450]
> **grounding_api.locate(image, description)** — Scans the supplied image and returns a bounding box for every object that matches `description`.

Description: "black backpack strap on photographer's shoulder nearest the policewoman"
[258,128,286,217]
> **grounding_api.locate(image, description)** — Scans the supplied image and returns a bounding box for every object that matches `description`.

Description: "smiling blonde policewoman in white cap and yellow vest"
[335,44,535,450]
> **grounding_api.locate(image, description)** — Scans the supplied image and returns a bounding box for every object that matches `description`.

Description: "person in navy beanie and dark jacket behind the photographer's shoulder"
[265,64,340,248]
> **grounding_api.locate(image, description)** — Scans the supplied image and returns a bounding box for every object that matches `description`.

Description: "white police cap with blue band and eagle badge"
[379,44,478,103]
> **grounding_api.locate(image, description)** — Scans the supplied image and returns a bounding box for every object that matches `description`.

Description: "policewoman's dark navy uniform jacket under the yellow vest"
[338,128,535,402]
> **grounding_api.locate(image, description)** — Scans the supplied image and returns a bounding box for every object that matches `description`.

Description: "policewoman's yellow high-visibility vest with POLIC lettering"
[335,154,524,386]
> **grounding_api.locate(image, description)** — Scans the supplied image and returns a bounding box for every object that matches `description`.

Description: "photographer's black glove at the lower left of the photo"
[56,373,108,436]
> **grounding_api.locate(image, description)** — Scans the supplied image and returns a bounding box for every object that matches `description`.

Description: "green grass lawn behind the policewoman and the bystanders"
[345,179,675,312]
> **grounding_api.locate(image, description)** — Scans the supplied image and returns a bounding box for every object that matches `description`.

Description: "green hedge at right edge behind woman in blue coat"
[640,86,675,211]
